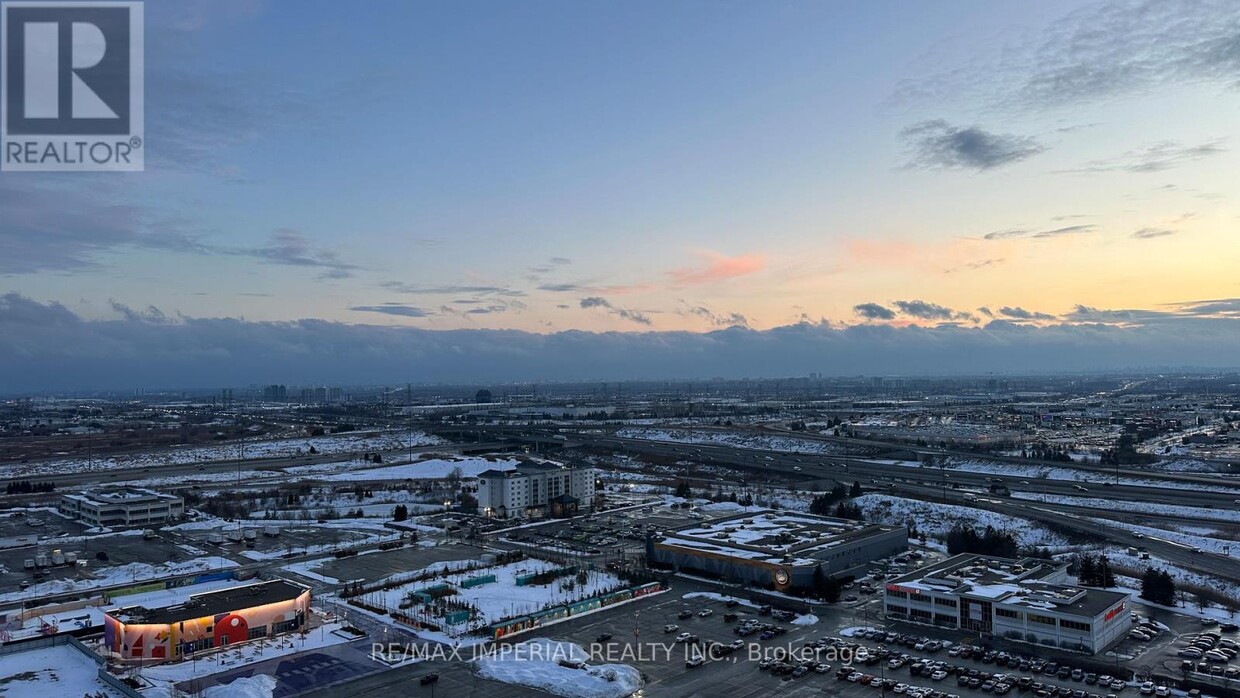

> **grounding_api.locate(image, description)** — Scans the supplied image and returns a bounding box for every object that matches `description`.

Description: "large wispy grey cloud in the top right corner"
[894,0,1240,113]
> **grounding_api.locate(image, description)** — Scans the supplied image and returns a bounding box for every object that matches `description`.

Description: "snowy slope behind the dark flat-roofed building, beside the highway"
[853,495,1068,548]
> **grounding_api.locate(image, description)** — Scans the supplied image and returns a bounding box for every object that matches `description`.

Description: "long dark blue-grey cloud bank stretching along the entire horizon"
[0,294,1240,393]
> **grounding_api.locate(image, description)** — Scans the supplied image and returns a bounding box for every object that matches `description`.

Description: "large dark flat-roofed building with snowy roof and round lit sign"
[646,510,909,590]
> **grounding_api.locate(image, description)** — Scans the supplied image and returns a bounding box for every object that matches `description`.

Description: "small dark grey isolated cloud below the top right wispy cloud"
[900,119,1045,171]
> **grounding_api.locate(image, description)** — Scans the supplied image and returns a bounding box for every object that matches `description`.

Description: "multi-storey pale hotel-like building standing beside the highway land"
[477,461,596,518]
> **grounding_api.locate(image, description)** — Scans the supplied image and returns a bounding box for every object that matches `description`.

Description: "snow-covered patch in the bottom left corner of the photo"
[0,645,120,698]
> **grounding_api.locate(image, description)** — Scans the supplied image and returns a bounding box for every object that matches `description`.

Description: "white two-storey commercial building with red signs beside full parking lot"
[883,554,1131,655]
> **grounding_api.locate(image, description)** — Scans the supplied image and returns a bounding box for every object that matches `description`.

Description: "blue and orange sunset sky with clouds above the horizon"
[0,0,1240,391]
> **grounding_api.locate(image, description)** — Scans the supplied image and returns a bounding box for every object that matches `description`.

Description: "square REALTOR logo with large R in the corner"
[0,1,145,172]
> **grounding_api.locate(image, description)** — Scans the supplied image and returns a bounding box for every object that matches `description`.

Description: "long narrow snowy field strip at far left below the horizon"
[5,430,444,477]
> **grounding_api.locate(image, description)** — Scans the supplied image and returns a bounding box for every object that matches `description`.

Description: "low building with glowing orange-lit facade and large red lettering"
[103,579,310,660]
